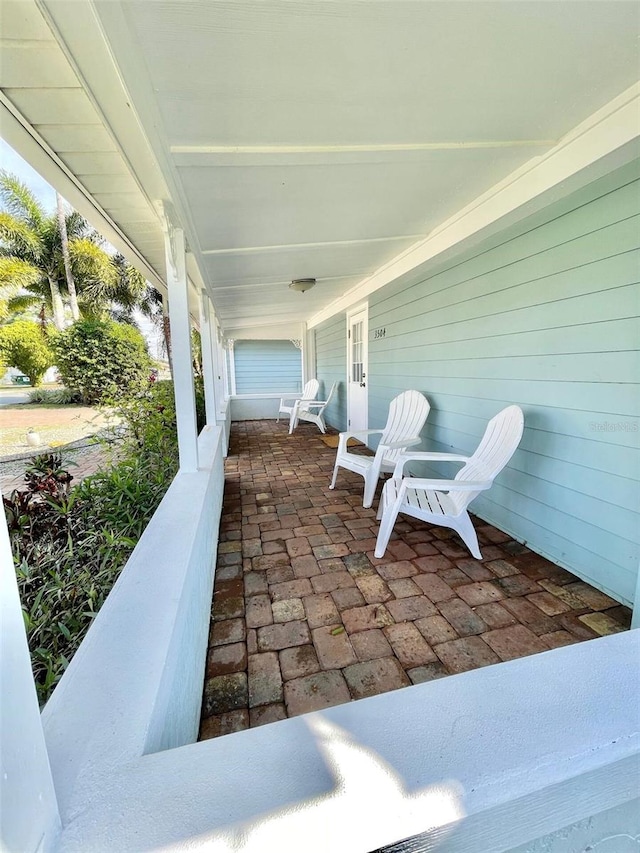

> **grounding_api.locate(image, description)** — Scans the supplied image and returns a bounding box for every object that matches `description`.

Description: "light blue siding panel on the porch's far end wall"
[233,341,302,394]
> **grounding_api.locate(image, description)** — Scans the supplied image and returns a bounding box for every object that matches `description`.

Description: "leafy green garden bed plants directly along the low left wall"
[4,382,185,703]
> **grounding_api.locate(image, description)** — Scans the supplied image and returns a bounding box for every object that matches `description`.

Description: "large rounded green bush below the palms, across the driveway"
[52,320,151,405]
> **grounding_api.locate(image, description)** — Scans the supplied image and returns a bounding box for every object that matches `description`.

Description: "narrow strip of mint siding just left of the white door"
[315,314,347,430]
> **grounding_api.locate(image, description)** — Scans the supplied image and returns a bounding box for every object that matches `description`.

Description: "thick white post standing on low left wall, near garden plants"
[164,223,198,473]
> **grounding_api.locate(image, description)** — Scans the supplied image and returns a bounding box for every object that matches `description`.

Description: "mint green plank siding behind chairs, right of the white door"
[369,165,640,603]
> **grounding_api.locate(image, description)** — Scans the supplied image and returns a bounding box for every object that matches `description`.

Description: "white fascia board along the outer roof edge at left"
[0,92,167,294]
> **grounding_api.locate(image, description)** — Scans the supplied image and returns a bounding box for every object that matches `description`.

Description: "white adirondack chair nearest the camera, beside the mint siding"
[375,406,524,560]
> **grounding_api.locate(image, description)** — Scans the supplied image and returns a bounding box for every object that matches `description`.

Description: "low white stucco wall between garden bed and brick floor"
[42,427,224,815]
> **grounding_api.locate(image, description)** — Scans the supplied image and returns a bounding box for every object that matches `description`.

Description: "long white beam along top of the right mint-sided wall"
[307,82,640,328]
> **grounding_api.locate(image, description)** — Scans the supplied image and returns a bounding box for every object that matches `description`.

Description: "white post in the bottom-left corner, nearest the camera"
[0,496,60,853]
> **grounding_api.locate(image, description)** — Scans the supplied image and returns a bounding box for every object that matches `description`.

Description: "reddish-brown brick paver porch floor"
[200,421,631,739]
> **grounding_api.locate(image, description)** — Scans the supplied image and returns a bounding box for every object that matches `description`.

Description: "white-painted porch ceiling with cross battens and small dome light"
[0,0,640,333]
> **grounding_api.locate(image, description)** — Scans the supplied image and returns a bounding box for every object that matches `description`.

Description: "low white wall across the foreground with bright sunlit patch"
[54,632,640,853]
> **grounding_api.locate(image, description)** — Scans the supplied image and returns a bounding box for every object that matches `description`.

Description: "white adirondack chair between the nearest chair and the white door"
[329,391,430,507]
